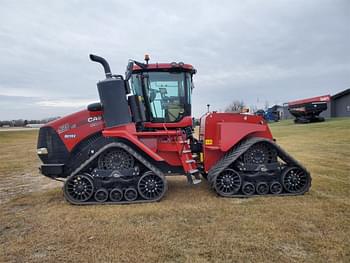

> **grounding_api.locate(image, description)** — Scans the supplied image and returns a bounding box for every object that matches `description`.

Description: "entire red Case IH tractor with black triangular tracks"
[37,55,311,204]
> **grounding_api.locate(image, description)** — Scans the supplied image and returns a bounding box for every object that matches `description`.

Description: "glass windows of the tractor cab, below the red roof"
[131,72,191,122]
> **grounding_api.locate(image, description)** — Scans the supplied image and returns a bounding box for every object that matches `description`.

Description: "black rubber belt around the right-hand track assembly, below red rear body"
[208,137,311,198]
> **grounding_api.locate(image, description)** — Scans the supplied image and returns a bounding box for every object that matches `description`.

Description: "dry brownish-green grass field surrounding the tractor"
[0,118,350,262]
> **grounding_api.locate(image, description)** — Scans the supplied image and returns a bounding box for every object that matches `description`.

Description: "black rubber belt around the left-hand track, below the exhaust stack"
[63,142,168,205]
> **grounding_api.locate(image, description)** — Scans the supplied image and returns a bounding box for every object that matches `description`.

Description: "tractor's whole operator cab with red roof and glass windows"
[126,56,196,123]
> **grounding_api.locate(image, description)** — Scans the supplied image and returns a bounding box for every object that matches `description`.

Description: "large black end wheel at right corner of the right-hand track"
[282,167,310,193]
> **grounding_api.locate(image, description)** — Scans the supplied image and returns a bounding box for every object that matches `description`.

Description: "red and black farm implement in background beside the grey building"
[288,95,331,123]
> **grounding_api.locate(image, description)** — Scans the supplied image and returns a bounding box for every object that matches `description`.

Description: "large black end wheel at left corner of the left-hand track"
[63,174,94,203]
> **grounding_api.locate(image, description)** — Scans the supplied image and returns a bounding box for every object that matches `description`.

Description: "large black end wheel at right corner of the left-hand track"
[137,171,165,200]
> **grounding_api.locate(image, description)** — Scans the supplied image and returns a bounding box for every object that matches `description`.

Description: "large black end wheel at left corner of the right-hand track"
[214,169,242,196]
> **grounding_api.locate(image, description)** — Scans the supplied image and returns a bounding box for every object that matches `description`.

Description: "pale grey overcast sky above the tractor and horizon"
[0,0,350,119]
